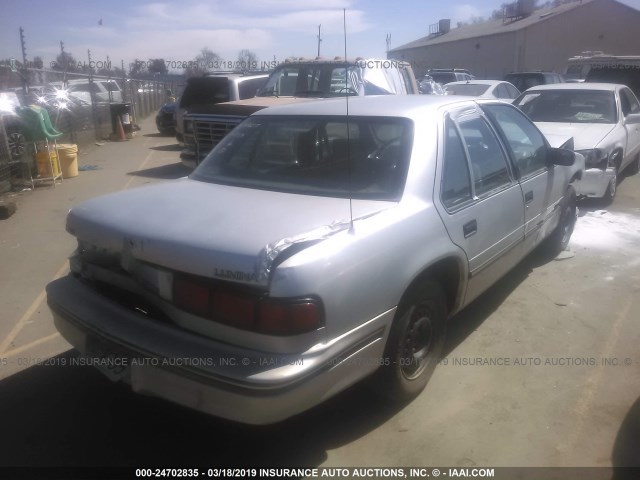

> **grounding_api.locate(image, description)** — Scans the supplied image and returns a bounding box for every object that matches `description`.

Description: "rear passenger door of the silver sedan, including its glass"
[436,108,524,303]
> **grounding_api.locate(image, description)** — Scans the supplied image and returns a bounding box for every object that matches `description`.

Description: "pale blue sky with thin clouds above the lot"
[0,0,640,73]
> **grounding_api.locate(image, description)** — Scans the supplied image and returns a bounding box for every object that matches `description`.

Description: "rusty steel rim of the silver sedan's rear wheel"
[400,304,435,380]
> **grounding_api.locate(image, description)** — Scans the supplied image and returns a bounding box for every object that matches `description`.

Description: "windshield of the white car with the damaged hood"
[514,90,617,123]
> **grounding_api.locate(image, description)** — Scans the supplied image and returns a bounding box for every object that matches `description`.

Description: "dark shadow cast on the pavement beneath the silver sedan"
[0,248,546,467]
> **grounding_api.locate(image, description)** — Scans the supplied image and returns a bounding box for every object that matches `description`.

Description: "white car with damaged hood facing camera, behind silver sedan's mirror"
[513,83,640,201]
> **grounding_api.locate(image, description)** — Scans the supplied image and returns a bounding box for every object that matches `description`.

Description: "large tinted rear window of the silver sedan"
[190,115,413,200]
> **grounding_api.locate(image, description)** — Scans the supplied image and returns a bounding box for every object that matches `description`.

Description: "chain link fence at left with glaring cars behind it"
[0,69,177,193]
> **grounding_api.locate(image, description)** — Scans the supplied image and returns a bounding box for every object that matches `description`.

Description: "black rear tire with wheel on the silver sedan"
[373,280,447,401]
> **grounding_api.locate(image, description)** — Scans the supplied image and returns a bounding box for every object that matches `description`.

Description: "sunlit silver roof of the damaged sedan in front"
[254,95,476,119]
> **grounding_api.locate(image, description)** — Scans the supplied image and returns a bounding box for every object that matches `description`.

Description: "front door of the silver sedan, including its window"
[482,104,569,251]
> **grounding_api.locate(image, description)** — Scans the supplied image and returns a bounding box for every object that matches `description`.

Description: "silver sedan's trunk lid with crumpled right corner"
[67,179,395,287]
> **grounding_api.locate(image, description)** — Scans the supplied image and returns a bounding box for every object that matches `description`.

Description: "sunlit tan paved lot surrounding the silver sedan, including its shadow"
[0,119,640,467]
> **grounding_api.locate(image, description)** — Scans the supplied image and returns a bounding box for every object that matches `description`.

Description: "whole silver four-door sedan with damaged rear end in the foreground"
[47,95,583,424]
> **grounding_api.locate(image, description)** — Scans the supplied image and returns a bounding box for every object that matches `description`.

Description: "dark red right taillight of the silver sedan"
[173,274,324,335]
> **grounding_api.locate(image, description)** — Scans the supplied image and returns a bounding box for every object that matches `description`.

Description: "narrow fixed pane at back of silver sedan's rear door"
[440,118,473,210]
